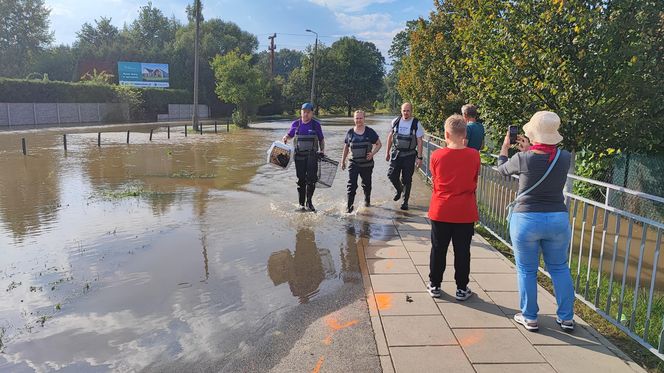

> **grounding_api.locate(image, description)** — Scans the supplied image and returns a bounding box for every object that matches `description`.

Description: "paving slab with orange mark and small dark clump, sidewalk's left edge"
[374,293,440,316]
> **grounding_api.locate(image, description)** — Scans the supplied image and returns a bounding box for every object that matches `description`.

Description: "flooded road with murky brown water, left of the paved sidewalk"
[0,118,430,372]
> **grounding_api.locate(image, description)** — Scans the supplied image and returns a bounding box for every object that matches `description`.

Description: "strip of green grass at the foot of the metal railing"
[475,224,664,373]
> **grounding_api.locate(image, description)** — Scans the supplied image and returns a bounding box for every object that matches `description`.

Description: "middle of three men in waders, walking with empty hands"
[341,110,381,213]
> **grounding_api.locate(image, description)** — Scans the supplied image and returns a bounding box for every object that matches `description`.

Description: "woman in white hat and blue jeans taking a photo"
[498,111,574,331]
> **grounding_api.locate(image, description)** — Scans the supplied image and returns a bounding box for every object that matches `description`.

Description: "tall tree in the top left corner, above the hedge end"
[0,0,53,77]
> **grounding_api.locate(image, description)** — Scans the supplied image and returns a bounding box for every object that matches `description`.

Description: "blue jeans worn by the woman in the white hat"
[510,212,574,320]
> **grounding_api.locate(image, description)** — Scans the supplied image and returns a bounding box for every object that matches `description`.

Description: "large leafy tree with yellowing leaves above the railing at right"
[399,0,664,152]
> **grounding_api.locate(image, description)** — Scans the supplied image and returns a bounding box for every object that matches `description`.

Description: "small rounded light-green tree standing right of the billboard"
[211,51,268,127]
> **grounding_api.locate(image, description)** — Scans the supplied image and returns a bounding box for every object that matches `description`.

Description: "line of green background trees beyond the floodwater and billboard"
[0,0,385,124]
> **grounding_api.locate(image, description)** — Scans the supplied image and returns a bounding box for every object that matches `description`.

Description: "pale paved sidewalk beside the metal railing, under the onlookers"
[358,210,645,373]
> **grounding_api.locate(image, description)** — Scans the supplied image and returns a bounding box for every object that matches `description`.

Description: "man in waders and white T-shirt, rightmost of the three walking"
[385,102,424,210]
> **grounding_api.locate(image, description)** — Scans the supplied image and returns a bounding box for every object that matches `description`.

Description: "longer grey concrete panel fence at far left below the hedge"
[0,103,129,128]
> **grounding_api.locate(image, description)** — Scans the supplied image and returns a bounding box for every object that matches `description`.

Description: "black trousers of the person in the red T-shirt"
[429,220,475,290]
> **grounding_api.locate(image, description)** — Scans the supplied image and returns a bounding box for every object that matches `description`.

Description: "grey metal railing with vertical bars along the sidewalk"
[420,135,664,360]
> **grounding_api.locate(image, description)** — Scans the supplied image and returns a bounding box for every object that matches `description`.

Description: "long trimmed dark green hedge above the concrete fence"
[0,78,195,120]
